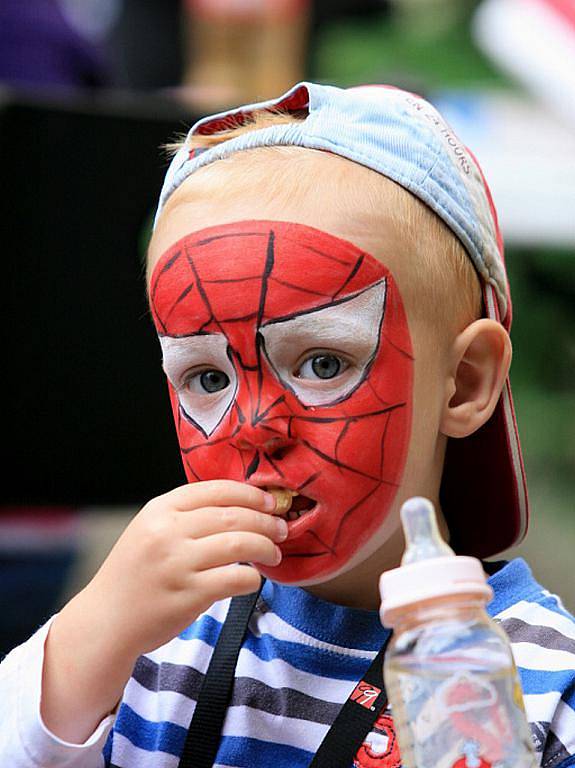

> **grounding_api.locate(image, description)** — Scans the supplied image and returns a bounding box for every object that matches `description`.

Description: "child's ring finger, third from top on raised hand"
[190,531,282,571]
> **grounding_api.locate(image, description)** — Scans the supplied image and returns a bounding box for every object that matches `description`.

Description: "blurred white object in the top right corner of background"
[473,0,575,125]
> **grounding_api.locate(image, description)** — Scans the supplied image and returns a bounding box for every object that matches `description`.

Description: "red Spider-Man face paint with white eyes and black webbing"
[150,221,413,583]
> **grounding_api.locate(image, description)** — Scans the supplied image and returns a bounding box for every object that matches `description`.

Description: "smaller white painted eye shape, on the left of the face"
[160,333,237,437]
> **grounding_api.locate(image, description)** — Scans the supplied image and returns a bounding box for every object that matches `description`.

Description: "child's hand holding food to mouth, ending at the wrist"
[84,480,287,658]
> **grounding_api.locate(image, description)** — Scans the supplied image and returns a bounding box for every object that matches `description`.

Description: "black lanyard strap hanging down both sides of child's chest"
[178,587,389,768]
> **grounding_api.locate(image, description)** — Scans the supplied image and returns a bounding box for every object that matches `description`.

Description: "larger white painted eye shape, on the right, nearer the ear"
[259,280,386,406]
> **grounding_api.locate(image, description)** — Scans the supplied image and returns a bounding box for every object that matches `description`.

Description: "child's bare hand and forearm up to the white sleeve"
[41,480,287,743]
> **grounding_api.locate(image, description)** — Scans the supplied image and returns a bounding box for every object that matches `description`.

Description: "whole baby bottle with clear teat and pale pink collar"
[380,498,536,768]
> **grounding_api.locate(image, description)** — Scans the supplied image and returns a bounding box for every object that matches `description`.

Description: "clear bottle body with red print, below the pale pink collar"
[384,595,536,768]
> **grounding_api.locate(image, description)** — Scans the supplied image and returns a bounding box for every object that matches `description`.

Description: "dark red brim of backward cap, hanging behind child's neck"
[441,284,528,558]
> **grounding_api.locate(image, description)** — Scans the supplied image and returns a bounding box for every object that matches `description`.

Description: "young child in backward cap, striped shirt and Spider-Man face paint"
[0,84,575,768]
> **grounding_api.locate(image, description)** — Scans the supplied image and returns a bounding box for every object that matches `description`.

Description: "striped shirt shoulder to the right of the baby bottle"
[489,559,575,766]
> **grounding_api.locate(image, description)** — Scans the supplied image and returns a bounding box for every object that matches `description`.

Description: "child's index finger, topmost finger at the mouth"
[159,480,276,512]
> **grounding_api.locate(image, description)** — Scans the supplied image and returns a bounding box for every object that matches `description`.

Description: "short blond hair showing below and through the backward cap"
[156,110,482,333]
